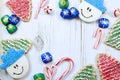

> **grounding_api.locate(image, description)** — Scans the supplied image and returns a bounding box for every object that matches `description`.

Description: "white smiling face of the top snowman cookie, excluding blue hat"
[79,1,102,22]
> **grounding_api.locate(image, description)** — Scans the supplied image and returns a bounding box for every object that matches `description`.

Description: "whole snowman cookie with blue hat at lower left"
[0,48,29,79]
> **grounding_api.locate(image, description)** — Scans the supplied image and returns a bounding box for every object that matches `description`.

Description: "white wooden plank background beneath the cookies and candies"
[0,0,120,80]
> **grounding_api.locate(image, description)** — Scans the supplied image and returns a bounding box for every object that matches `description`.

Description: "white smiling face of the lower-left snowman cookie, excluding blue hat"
[7,55,29,78]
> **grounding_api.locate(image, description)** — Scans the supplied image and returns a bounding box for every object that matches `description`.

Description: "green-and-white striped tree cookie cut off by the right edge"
[105,21,120,49]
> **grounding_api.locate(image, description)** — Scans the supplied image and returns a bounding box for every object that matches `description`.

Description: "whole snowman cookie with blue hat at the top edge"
[79,0,106,22]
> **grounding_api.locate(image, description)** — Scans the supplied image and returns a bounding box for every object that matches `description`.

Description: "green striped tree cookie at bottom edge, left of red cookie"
[73,65,96,80]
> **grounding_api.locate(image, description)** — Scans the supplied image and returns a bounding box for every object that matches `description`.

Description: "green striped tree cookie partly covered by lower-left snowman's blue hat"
[1,39,32,53]
